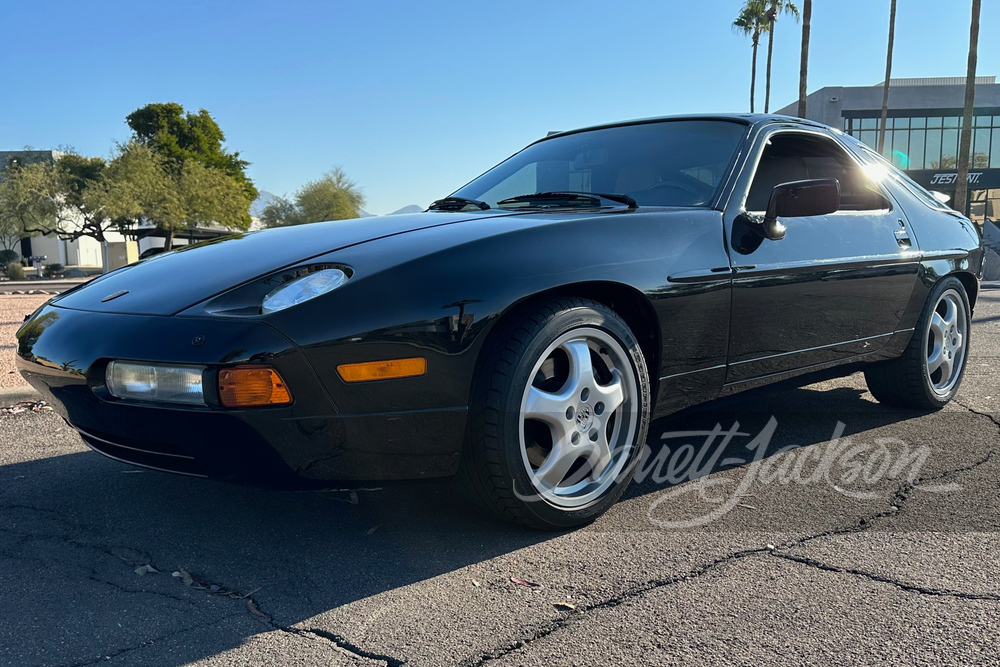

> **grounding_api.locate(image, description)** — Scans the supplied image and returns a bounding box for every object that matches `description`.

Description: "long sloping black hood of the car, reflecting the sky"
[53,212,511,315]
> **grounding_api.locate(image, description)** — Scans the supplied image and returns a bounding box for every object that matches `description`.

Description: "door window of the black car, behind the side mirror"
[746,132,887,211]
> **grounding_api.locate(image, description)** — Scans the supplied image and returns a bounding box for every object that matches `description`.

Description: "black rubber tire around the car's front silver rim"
[459,297,650,530]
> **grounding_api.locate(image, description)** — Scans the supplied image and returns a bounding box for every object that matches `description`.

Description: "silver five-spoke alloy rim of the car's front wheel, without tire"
[519,327,640,509]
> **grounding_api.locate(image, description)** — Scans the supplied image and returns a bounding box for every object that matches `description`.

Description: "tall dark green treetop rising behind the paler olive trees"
[125,102,258,229]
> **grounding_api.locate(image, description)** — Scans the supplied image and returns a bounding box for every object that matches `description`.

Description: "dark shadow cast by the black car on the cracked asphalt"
[0,380,944,665]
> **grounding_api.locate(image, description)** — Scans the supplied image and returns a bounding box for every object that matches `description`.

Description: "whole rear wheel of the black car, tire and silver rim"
[865,277,972,410]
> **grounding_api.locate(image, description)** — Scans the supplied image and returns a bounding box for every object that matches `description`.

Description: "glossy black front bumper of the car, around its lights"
[17,305,466,488]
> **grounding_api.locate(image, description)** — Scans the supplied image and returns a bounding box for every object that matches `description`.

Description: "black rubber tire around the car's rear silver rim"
[865,276,972,410]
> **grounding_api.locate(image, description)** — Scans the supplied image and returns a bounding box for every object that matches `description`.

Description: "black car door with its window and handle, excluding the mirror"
[725,129,918,384]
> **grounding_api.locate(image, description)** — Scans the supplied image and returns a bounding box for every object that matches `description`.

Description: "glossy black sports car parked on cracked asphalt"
[17,115,983,527]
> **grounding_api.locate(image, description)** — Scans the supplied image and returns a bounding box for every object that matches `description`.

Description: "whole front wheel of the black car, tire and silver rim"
[460,298,650,529]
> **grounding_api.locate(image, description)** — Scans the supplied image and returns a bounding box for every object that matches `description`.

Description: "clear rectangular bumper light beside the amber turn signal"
[105,361,205,405]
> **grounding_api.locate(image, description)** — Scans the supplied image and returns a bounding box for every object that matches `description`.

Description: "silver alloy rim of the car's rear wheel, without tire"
[926,289,969,396]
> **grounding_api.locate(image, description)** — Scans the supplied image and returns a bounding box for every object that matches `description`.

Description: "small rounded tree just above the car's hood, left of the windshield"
[261,167,365,227]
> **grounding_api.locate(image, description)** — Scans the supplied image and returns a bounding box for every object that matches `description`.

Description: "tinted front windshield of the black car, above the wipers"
[454,120,747,208]
